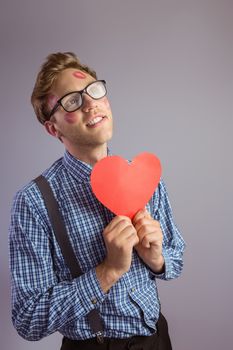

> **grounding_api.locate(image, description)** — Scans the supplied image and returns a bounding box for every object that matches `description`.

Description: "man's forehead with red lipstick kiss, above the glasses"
[52,68,95,97]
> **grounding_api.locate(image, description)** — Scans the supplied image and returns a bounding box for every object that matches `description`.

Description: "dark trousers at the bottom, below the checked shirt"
[61,314,172,350]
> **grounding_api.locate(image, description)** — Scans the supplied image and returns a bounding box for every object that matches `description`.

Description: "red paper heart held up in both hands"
[91,152,161,219]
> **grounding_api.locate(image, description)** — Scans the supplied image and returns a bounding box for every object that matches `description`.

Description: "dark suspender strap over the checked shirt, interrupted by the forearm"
[34,175,103,343]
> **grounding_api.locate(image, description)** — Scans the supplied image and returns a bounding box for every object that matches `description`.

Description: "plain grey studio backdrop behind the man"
[0,0,233,350]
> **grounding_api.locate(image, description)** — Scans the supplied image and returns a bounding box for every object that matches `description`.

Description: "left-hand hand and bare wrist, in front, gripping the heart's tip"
[96,216,139,292]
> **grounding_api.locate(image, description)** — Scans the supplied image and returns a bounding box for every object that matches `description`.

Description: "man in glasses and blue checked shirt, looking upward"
[10,52,184,350]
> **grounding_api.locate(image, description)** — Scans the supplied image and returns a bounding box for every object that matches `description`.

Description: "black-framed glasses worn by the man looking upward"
[48,80,107,119]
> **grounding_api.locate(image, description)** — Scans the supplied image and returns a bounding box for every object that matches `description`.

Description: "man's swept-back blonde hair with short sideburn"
[31,52,97,124]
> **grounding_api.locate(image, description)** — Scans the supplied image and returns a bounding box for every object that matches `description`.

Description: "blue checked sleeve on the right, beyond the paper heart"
[151,180,185,280]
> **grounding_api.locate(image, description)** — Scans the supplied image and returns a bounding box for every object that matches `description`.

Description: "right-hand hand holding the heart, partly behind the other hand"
[132,209,164,273]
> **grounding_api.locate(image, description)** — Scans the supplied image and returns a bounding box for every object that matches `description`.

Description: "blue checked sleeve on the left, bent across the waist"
[9,192,106,340]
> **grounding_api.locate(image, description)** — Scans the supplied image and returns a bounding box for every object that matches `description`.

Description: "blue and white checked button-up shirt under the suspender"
[9,152,185,340]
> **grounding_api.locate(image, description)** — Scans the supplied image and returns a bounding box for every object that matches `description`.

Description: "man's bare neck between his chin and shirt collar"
[66,143,107,166]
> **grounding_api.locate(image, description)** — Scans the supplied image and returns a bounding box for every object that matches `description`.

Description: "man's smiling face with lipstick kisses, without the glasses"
[46,68,113,148]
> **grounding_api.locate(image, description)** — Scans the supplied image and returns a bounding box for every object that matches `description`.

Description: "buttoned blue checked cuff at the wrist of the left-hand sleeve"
[76,268,106,312]
